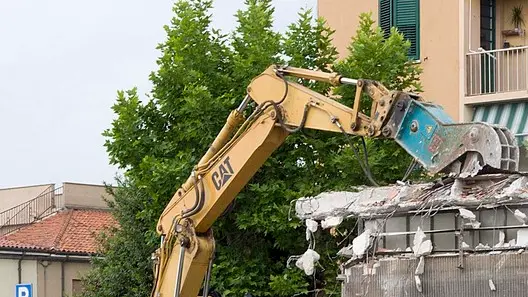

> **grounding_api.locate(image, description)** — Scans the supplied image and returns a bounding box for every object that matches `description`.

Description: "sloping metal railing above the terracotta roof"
[0,186,64,235]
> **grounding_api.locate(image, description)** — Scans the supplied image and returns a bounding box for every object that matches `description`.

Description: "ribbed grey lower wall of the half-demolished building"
[342,252,528,297]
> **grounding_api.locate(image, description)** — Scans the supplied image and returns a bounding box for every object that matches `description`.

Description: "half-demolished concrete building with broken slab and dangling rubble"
[295,174,528,297]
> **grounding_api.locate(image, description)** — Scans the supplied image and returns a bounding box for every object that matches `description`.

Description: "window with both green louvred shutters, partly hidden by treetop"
[379,0,420,60]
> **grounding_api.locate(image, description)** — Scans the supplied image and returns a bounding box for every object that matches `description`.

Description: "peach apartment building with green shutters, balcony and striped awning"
[317,0,528,141]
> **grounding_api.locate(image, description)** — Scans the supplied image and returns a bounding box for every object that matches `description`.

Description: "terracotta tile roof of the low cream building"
[0,209,116,254]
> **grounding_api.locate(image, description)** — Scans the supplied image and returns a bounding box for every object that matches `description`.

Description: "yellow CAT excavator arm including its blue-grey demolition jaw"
[151,65,519,297]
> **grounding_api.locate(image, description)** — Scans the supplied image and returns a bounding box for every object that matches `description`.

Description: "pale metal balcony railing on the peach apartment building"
[466,46,528,96]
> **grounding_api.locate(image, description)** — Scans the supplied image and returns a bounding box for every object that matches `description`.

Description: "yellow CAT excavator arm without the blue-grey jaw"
[152,66,392,297]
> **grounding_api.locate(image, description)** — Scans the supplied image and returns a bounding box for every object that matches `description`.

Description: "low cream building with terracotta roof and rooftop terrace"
[0,183,115,297]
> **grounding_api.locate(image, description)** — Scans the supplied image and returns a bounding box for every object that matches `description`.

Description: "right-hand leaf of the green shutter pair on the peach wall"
[393,0,420,60]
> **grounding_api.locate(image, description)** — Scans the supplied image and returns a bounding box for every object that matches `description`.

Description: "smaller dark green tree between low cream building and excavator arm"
[80,180,153,297]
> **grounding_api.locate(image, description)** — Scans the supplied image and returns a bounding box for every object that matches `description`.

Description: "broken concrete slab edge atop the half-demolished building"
[295,174,528,220]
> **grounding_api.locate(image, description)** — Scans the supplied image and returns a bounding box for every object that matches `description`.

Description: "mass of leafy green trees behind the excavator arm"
[83,0,419,297]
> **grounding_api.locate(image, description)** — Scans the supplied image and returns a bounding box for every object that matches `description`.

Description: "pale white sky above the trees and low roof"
[0,0,317,187]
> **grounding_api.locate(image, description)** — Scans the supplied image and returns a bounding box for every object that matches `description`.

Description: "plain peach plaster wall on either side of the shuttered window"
[318,0,462,120]
